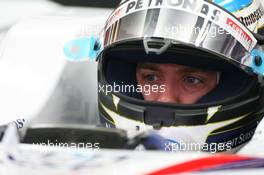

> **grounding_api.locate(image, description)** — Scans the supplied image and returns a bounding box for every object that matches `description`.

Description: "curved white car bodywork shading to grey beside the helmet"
[0,5,111,127]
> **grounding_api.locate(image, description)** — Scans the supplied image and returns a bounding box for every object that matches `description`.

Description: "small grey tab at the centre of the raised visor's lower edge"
[143,37,171,55]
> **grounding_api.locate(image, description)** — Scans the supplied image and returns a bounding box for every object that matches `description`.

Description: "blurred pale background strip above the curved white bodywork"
[0,0,120,44]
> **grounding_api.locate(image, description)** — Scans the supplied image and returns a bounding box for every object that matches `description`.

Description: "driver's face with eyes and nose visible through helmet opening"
[136,63,217,104]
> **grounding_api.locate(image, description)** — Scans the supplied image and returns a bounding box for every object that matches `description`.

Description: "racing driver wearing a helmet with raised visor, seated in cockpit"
[95,0,264,152]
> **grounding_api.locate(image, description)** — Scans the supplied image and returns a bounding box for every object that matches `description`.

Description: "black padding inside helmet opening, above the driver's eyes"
[106,46,235,71]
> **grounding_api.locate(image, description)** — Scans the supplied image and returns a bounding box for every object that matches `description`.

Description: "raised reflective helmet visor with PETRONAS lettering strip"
[103,0,262,73]
